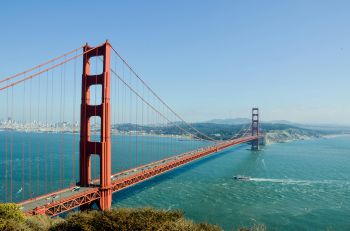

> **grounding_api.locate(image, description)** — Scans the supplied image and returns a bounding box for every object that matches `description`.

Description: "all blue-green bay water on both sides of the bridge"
[0,132,350,230]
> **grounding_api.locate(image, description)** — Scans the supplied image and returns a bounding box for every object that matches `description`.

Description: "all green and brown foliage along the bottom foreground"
[0,204,221,231]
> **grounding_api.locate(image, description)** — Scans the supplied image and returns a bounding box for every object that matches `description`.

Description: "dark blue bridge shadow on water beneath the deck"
[112,144,250,205]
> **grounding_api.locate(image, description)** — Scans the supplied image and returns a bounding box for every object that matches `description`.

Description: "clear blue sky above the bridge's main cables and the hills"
[0,0,350,125]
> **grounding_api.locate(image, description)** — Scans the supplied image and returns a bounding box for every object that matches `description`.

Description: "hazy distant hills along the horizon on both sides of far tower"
[112,118,350,143]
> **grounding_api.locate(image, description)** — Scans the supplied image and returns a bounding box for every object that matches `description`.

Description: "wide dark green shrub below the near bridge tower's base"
[50,208,221,231]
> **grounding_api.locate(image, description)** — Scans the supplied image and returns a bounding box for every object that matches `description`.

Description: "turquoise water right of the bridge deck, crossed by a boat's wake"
[113,136,350,230]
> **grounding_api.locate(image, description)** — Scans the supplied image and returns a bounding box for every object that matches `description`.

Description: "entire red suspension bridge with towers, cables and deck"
[0,41,262,216]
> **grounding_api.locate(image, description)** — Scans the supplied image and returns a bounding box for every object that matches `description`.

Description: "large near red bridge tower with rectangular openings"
[80,41,112,210]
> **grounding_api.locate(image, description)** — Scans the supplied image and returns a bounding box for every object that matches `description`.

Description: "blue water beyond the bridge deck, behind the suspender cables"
[0,131,210,202]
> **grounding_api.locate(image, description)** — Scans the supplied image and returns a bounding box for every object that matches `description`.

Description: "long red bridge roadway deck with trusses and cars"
[19,136,259,216]
